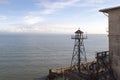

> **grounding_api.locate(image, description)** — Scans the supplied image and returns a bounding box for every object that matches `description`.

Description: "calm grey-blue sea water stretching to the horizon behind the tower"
[0,34,108,80]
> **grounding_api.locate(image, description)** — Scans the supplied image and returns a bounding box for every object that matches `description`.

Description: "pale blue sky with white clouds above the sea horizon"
[0,0,120,34]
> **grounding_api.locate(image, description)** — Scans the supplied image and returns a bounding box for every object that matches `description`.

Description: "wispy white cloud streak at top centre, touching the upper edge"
[39,0,79,14]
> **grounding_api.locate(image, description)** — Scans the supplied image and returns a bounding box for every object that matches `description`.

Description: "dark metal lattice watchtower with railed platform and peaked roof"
[71,30,87,72]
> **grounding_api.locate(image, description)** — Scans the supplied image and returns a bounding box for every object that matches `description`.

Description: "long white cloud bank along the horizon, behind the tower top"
[0,22,107,34]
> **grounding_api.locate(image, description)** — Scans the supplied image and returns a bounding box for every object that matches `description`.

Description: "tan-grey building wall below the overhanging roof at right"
[108,9,120,80]
